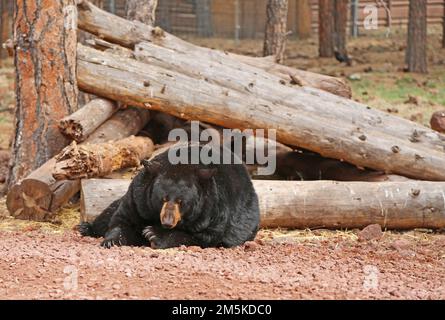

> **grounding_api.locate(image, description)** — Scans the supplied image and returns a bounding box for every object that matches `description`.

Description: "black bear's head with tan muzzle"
[143,160,217,229]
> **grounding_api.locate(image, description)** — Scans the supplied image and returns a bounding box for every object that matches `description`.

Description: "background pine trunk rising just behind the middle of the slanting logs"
[263,0,288,63]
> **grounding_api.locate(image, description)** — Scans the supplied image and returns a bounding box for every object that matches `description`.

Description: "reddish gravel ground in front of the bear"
[0,229,445,299]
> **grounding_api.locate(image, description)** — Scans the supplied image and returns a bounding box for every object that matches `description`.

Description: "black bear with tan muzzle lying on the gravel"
[79,144,260,249]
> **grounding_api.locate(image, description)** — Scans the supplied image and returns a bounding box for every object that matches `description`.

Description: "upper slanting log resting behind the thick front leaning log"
[135,42,445,158]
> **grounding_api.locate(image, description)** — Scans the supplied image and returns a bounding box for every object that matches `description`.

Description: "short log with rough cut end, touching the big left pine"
[59,98,119,142]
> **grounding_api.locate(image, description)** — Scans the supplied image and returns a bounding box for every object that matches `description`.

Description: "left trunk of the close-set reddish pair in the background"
[318,0,334,58]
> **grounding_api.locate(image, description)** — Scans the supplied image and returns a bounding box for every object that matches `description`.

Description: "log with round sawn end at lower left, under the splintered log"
[6,108,150,221]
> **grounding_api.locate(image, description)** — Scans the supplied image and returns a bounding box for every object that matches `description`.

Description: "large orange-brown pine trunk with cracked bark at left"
[8,0,78,186]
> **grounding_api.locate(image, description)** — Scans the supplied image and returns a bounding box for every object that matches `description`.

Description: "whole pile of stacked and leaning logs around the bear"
[7,1,445,229]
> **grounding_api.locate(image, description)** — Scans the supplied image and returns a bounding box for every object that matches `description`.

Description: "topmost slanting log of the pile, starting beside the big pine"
[78,0,351,98]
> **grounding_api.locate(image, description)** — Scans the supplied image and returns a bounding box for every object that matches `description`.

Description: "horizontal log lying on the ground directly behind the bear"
[81,179,445,230]
